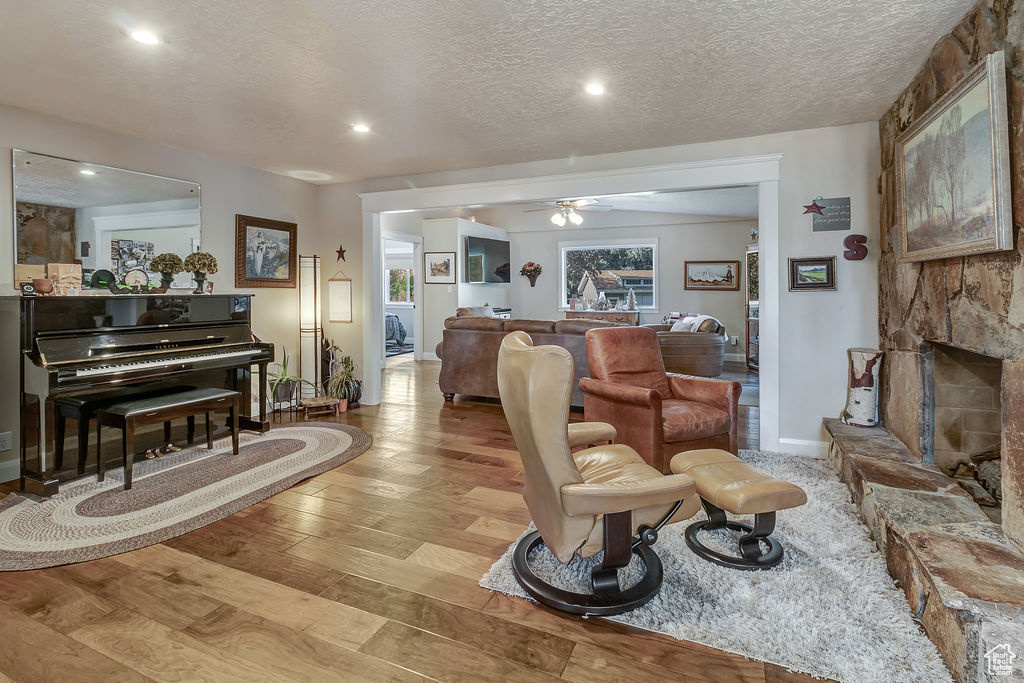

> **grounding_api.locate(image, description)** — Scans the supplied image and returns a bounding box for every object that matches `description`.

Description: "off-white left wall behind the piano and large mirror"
[0,105,317,479]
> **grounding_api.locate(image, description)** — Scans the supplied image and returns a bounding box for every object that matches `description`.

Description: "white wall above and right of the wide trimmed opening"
[321,122,880,453]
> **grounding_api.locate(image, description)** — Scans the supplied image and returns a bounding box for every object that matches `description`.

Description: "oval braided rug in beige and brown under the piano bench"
[0,423,373,571]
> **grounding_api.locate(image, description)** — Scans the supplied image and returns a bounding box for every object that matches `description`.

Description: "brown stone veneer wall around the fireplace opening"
[879,0,1024,545]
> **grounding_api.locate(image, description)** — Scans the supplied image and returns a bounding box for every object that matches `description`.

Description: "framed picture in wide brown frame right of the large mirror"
[234,214,298,288]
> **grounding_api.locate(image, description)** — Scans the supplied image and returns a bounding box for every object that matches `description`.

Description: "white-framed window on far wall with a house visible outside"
[559,243,657,308]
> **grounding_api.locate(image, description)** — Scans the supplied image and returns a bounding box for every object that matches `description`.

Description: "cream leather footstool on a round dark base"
[670,449,807,569]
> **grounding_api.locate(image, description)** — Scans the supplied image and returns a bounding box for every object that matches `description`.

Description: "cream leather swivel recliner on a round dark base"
[498,331,700,614]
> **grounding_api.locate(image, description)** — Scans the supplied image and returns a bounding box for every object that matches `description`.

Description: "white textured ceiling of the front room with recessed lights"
[0,0,973,181]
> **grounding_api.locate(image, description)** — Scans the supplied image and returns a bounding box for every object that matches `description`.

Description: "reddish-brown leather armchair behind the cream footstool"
[580,328,740,472]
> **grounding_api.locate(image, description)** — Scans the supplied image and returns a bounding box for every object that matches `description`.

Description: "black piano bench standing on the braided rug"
[96,389,242,489]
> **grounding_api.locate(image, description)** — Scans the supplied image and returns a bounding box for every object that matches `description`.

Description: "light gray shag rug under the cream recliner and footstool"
[480,451,951,683]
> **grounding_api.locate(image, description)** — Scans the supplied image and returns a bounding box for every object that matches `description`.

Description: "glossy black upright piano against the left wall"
[20,294,273,495]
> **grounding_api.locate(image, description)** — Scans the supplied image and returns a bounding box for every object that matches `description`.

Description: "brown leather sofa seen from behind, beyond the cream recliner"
[435,315,616,407]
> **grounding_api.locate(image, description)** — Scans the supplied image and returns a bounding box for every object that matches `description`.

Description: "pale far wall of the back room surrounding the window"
[477,206,751,353]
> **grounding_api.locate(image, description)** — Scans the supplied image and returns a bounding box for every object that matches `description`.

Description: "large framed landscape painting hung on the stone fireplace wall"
[896,52,1013,261]
